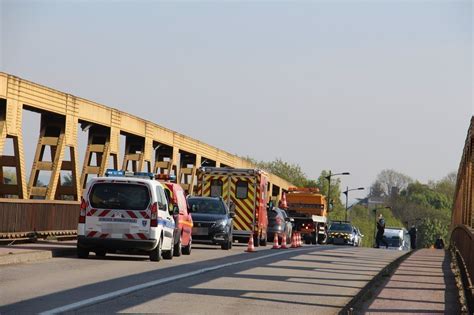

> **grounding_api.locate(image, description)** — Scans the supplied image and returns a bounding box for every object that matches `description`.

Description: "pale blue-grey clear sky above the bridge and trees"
[0,0,474,201]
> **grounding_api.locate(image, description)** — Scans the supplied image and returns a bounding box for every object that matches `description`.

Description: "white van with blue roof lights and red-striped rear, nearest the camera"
[77,170,175,261]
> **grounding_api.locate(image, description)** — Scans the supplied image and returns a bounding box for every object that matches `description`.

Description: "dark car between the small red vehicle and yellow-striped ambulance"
[188,197,235,250]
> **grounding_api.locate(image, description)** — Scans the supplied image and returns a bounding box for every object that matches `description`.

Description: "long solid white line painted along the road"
[39,247,309,315]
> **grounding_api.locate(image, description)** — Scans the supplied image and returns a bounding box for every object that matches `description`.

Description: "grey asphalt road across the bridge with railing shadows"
[0,244,401,314]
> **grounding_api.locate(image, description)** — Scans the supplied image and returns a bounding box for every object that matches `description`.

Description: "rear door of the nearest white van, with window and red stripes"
[85,180,151,239]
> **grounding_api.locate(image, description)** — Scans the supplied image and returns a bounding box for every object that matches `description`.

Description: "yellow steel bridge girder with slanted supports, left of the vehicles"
[0,72,291,202]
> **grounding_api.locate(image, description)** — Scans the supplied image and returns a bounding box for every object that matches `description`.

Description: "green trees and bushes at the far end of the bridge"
[247,158,456,247]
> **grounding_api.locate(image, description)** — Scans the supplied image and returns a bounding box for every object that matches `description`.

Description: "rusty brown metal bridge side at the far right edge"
[451,117,474,305]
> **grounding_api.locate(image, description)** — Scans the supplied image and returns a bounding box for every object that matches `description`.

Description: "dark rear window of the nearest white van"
[89,183,150,210]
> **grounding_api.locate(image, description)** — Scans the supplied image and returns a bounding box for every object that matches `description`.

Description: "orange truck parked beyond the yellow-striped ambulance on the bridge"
[286,187,328,244]
